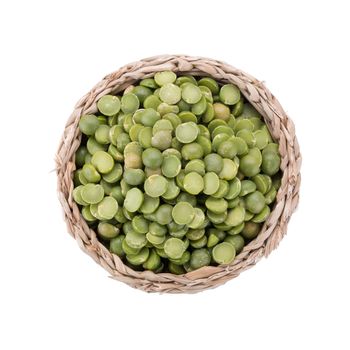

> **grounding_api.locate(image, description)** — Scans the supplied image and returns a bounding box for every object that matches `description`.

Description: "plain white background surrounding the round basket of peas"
[0,0,350,350]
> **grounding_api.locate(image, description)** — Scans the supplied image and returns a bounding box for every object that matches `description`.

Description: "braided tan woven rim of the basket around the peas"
[56,55,301,293]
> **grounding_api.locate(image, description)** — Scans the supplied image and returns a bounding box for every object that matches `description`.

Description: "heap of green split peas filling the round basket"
[73,71,281,274]
